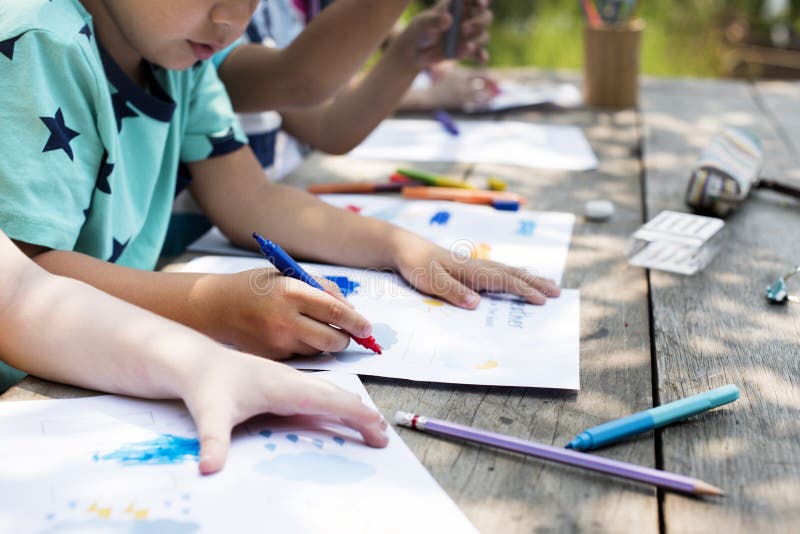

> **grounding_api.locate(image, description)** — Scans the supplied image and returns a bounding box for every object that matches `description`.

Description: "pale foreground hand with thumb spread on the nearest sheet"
[181,354,388,474]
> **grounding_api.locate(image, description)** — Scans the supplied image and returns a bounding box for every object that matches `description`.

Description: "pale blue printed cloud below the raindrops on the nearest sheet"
[255,451,375,484]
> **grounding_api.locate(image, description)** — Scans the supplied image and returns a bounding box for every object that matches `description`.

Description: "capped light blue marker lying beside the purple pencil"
[567,384,739,451]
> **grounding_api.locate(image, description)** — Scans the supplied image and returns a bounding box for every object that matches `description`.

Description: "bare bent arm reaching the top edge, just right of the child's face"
[219,0,412,112]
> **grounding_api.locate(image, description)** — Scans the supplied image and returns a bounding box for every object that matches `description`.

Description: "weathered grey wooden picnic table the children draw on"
[2,69,800,533]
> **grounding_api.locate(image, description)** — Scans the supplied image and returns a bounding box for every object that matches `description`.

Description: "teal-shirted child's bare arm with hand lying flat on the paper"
[190,147,560,308]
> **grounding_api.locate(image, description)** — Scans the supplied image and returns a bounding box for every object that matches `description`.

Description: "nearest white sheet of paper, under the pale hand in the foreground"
[0,373,476,534]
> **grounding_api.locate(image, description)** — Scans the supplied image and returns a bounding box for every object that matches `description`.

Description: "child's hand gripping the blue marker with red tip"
[200,268,372,360]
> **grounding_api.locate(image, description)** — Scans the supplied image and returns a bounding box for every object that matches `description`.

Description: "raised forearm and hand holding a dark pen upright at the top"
[281,1,492,154]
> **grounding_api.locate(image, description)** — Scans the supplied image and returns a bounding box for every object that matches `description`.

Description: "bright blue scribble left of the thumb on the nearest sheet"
[94,434,200,465]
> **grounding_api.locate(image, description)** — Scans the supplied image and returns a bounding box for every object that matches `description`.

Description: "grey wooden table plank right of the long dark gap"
[643,76,800,532]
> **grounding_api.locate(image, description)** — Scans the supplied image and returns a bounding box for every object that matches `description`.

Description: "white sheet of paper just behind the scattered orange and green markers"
[348,119,597,171]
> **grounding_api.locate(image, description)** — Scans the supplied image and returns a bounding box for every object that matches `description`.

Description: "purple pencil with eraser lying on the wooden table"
[394,412,724,495]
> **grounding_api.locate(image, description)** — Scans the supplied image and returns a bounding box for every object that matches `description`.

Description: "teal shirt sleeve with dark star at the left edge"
[0,30,104,250]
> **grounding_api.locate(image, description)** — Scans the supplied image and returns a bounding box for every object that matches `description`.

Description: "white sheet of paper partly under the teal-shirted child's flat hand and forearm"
[189,195,575,283]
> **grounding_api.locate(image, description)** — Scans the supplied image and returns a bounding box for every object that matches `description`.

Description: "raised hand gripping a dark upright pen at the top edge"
[389,0,492,69]
